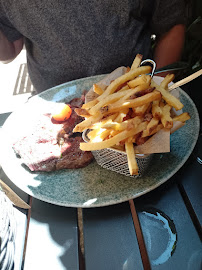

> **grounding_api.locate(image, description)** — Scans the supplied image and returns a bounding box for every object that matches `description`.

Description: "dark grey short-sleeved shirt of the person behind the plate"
[0,0,184,92]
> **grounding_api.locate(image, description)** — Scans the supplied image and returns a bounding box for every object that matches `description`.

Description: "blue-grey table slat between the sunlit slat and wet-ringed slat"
[83,203,143,270]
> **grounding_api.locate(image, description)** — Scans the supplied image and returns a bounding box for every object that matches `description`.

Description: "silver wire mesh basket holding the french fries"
[82,130,152,178]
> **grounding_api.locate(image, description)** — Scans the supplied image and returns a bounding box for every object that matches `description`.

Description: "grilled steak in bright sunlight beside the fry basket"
[13,97,93,171]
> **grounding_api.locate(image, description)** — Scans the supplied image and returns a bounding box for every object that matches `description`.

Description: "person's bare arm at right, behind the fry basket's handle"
[154,24,185,71]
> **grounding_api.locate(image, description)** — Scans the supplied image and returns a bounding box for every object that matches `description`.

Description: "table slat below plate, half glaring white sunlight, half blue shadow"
[24,198,79,270]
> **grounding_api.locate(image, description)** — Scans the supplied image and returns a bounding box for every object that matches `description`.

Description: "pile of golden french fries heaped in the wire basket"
[73,54,190,175]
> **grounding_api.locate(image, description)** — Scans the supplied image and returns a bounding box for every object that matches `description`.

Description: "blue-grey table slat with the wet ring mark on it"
[135,178,202,270]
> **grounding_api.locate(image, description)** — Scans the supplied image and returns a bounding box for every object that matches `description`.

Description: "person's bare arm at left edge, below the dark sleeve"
[0,31,23,64]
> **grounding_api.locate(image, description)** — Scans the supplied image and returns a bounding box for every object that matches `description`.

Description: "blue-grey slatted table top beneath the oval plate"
[0,76,202,270]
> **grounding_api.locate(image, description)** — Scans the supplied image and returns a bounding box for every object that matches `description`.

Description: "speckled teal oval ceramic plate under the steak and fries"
[0,75,199,207]
